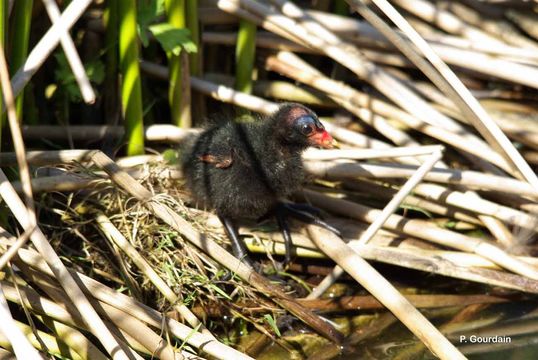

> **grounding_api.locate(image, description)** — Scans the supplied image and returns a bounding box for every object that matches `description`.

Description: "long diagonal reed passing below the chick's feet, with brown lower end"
[88,151,342,343]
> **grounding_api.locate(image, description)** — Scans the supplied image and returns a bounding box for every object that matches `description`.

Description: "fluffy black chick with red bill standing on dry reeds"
[182,103,339,263]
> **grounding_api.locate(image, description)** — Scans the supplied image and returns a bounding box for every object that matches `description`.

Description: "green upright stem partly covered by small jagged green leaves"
[165,0,192,128]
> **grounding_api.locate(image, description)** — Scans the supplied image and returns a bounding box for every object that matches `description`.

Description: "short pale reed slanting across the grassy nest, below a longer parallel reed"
[96,213,216,340]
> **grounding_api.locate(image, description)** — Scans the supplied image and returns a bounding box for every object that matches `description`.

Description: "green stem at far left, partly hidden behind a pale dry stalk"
[9,0,34,122]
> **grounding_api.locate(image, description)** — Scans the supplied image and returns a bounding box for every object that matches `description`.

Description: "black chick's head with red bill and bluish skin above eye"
[273,103,333,149]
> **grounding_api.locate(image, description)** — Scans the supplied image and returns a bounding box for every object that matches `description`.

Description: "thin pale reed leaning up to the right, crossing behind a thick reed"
[308,149,443,299]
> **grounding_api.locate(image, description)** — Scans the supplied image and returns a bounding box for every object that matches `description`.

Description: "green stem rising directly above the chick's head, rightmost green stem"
[235,20,256,94]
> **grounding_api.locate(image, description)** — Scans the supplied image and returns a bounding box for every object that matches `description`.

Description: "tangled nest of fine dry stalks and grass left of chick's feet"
[41,159,283,334]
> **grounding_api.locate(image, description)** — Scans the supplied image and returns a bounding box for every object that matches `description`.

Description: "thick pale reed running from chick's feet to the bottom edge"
[307,225,465,359]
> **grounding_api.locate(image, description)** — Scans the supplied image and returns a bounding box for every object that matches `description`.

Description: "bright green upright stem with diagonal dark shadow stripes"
[118,0,144,156]
